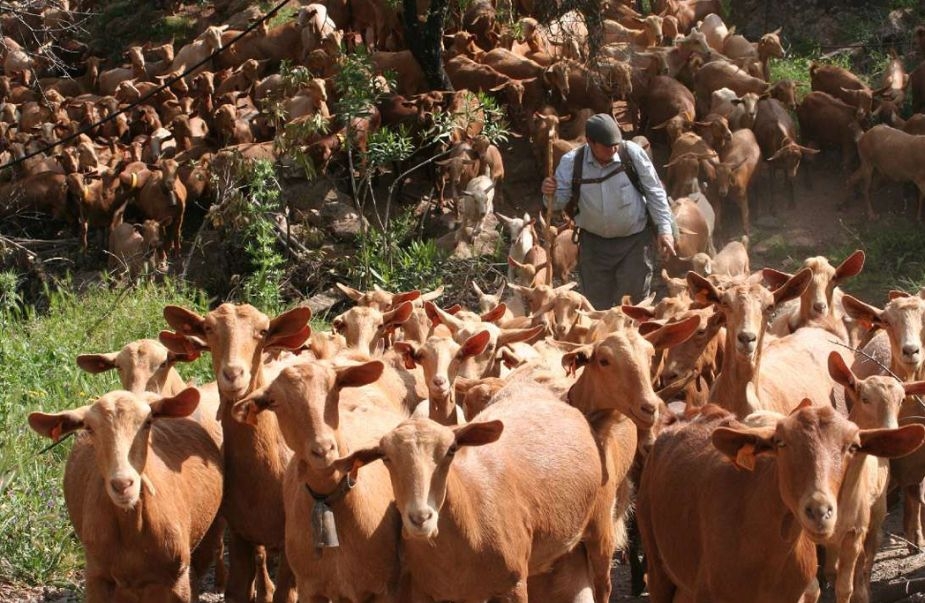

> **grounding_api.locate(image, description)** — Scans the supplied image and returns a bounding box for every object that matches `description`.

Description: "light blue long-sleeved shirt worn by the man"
[553,141,672,239]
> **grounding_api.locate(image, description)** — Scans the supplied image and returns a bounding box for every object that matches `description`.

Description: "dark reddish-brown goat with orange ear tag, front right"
[638,400,925,603]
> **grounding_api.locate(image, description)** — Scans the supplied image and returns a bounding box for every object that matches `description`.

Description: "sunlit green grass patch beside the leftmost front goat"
[0,283,211,584]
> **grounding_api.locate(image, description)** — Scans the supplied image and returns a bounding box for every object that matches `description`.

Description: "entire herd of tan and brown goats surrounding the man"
[9,0,925,603]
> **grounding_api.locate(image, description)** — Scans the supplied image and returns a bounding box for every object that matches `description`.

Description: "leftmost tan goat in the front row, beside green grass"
[29,389,223,603]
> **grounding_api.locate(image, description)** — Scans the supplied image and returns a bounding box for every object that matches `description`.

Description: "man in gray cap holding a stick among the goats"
[542,113,675,310]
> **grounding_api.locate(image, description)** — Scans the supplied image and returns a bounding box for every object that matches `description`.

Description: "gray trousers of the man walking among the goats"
[578,228,654,310]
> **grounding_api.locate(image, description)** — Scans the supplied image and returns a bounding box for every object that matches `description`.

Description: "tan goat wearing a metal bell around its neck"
[233,360,404,603]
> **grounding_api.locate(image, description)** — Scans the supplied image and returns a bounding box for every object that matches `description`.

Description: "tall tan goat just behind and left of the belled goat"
[160,303,311,601]
